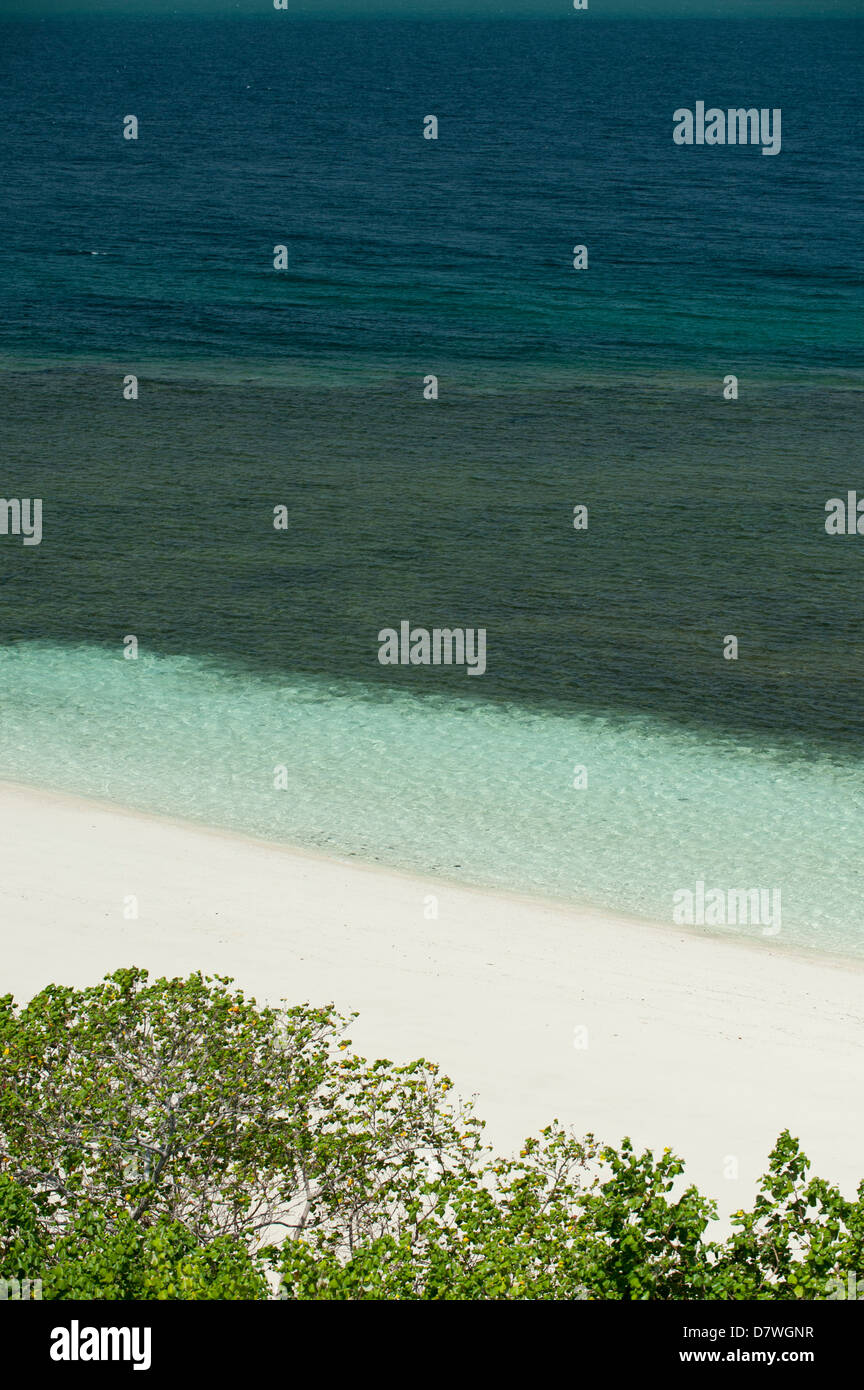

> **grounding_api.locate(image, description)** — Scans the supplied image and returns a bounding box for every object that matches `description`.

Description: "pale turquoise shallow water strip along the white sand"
[0,642,864,955]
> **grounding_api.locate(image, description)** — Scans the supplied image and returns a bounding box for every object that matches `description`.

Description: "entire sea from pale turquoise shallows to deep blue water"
[0,11,864,955]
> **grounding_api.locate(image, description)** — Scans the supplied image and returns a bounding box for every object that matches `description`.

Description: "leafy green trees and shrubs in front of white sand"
[0,969,864,1300]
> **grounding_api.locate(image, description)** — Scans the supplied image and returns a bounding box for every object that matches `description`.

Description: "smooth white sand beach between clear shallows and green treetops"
[0,785,864,1212]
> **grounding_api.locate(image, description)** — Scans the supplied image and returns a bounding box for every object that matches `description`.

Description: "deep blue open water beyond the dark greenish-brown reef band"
[0,11,864,385]
